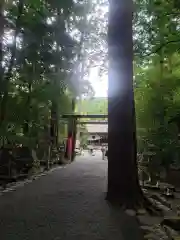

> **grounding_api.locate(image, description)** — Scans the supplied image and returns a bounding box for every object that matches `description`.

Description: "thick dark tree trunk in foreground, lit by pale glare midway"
[107,0,142,206]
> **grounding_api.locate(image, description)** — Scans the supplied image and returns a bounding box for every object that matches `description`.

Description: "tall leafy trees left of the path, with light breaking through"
[0,0,105,165]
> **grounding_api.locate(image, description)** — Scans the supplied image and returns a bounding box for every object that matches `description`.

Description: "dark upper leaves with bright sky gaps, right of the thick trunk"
[134,0,180,58]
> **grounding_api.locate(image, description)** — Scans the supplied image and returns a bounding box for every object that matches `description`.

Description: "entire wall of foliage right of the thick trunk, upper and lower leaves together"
[134,0,180,180]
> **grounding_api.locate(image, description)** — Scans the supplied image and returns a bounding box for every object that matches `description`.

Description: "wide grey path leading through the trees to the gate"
[0,153,141,240]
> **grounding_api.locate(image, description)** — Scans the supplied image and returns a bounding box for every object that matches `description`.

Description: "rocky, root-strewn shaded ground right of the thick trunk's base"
[136,183,180,240]
